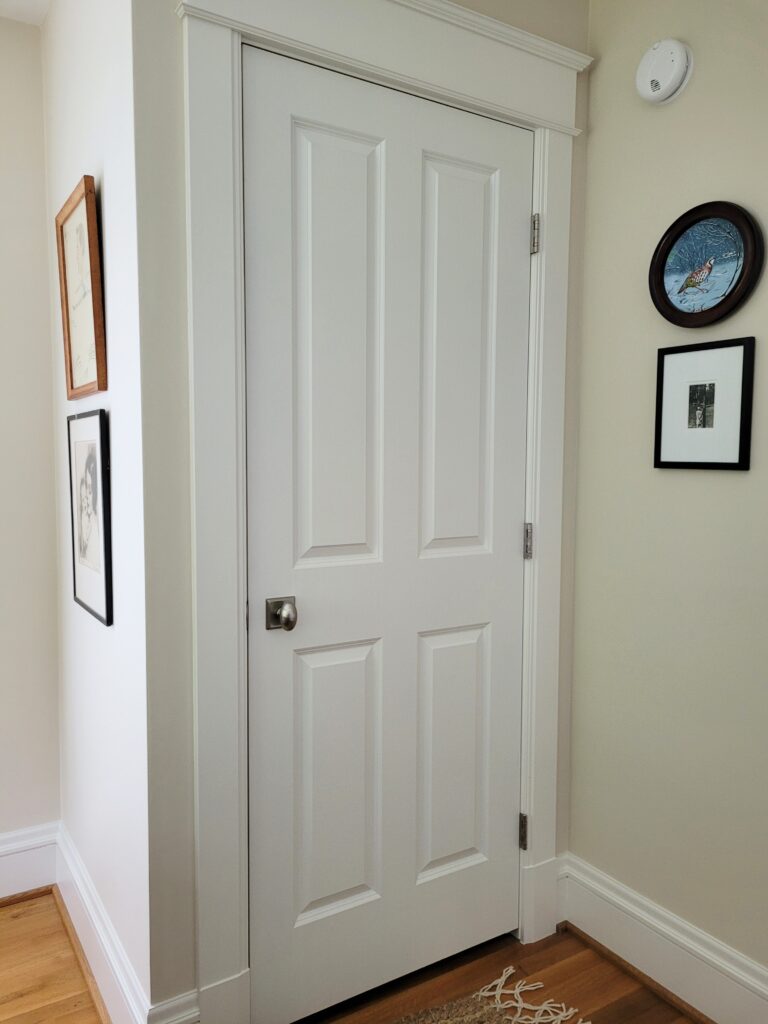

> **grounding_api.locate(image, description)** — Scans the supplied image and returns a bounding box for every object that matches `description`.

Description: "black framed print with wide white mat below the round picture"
[653,338,755,469]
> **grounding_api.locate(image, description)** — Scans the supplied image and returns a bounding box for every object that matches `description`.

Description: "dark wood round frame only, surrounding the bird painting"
[648,202,764,327]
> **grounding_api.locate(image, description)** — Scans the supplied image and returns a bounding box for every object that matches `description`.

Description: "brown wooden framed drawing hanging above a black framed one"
[56,174,106,398]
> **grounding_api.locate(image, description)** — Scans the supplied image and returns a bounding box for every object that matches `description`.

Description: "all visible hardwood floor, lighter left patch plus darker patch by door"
[0,890,712,1024]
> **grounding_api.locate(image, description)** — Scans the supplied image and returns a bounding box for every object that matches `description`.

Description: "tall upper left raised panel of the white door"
[292,121,383,565]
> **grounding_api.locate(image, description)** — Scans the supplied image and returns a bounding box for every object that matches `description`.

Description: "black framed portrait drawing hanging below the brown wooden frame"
[67,409,112,626]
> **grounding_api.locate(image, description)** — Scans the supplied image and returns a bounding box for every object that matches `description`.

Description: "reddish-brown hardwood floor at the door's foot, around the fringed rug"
[301,931,706,1024]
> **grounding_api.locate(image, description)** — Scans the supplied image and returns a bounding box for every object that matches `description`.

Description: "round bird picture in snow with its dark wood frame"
[648,203,763,327]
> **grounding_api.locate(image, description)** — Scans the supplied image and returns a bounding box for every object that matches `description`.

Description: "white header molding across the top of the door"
[176,0,592,135]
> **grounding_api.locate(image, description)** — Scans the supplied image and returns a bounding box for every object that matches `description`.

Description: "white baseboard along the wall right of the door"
[558,853,768,1024]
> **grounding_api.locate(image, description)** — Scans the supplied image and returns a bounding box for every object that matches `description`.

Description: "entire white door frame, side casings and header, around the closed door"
[177,0,591,1024]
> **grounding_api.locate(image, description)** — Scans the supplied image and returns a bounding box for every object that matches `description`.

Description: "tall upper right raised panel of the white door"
[421,155,499,555]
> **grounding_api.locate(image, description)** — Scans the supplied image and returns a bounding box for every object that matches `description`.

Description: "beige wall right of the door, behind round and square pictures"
[570,0,768,964]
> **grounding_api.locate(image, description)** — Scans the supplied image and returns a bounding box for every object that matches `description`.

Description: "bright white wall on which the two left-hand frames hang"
[42,0,150,993]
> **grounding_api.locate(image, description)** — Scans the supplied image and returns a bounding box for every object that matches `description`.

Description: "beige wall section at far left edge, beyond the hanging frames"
[0,18,58,834]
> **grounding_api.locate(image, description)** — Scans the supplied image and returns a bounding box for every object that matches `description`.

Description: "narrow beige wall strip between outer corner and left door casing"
[133,0,196,1001]
